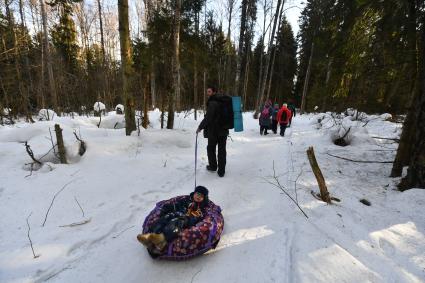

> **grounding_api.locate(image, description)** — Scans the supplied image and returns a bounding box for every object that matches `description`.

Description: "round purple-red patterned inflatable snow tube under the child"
[143,196,224,260]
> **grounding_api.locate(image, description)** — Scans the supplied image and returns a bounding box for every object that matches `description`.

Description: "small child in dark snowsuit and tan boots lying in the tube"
[137,186,208,252]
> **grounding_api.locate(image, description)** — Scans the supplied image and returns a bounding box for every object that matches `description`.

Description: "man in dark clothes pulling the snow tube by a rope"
[196,87,229,177]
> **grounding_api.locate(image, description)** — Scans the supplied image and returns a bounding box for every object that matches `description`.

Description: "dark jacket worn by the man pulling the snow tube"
[198,94,229,138]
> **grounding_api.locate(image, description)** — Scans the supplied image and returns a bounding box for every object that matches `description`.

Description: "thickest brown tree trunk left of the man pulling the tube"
[118,0,136,136]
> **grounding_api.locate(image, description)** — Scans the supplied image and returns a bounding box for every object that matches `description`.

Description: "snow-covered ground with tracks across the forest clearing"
[0,111,425,283]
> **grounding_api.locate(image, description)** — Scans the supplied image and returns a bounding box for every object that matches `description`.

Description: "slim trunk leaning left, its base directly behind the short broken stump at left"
[39,0,60,113]
